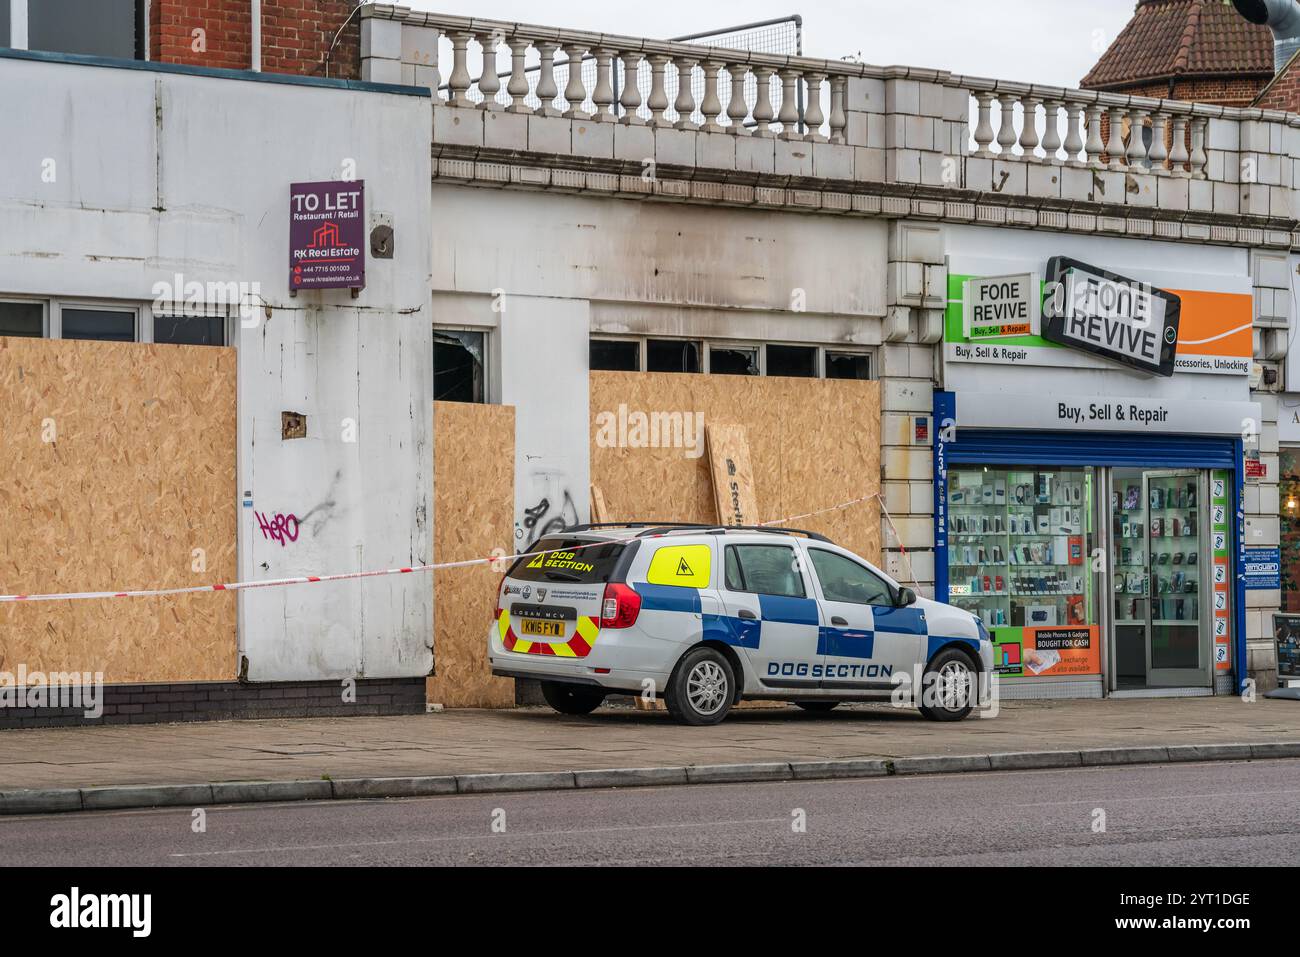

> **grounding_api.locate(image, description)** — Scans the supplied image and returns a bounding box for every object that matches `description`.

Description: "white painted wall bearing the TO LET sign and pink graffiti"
[0,57,433,680]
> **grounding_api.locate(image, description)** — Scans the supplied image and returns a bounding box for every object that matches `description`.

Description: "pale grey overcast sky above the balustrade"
[397,0,1136,87]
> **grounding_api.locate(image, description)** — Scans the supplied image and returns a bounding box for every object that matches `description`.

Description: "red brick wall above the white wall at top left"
[150,0,360,79]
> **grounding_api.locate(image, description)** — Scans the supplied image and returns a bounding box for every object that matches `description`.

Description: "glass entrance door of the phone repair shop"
[1112,468,1210,689]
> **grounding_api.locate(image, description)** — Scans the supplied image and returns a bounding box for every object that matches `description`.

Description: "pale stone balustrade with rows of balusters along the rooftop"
[361,4,1300,227]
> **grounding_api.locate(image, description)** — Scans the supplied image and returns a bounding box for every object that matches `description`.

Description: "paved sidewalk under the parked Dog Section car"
[0,697,1300,791]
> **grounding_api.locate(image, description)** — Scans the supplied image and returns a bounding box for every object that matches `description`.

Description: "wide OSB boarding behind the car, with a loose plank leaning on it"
[590,372,880,563]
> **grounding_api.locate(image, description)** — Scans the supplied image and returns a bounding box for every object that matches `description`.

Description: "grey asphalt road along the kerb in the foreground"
[0,761,1300,867]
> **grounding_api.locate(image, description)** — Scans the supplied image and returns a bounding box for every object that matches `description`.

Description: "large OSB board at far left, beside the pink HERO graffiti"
[0,338,238,683]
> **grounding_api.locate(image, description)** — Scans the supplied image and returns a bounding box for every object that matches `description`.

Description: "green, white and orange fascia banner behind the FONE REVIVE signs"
[944,264,1255,376]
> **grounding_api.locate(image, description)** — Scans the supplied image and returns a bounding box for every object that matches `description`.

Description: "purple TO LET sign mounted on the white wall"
[289,179,365,291]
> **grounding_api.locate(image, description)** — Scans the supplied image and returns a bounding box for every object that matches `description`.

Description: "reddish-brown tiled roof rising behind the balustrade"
[1079,0,1273,90]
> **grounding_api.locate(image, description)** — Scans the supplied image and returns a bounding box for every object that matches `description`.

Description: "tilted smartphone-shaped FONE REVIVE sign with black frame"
[1043,256,1182,376]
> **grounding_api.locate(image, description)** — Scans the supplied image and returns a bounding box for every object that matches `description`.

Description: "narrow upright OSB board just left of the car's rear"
[426,402,515,707]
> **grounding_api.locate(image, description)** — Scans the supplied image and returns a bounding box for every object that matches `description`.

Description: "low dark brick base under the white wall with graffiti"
[0,677,424,728]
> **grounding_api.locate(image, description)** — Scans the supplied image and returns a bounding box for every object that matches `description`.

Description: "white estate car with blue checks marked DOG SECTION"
[488,523,993,724]
